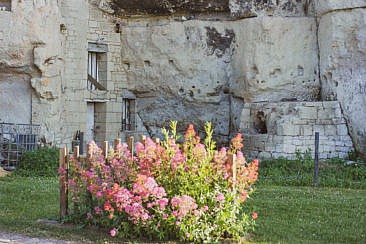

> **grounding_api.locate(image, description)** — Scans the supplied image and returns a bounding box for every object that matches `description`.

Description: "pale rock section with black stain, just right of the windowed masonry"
[121,21,235,139]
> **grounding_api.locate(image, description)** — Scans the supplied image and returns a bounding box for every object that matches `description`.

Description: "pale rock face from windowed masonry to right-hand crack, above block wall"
[121,17,320,141]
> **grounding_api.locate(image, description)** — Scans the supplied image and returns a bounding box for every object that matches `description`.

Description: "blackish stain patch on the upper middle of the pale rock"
[205,27,235,58]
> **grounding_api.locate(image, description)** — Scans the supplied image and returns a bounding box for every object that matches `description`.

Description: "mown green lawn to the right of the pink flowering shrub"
[249,185,366,243]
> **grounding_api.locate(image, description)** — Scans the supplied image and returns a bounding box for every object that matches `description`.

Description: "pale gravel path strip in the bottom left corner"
[0,233,80,244]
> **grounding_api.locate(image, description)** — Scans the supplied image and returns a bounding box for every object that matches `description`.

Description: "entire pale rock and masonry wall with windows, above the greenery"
[0,0,366,157]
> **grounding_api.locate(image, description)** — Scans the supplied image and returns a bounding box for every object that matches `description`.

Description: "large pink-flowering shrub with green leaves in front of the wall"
[60,122,258,241]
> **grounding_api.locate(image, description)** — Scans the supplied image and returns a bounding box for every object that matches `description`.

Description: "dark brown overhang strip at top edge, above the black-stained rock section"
[111,0,230,16]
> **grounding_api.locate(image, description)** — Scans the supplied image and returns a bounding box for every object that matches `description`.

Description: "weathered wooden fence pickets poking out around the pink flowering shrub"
[59,135,237,219]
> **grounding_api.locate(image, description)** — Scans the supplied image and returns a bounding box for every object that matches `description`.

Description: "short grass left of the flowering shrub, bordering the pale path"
[0,176,111,243]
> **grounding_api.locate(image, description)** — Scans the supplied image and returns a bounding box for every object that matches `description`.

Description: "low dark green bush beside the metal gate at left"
[15,147,59,176]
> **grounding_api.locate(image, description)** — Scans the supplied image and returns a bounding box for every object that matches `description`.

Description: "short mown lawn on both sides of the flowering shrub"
[0,176,366,243]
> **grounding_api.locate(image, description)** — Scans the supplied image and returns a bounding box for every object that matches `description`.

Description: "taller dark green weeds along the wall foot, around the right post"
[259,152,366,189]
